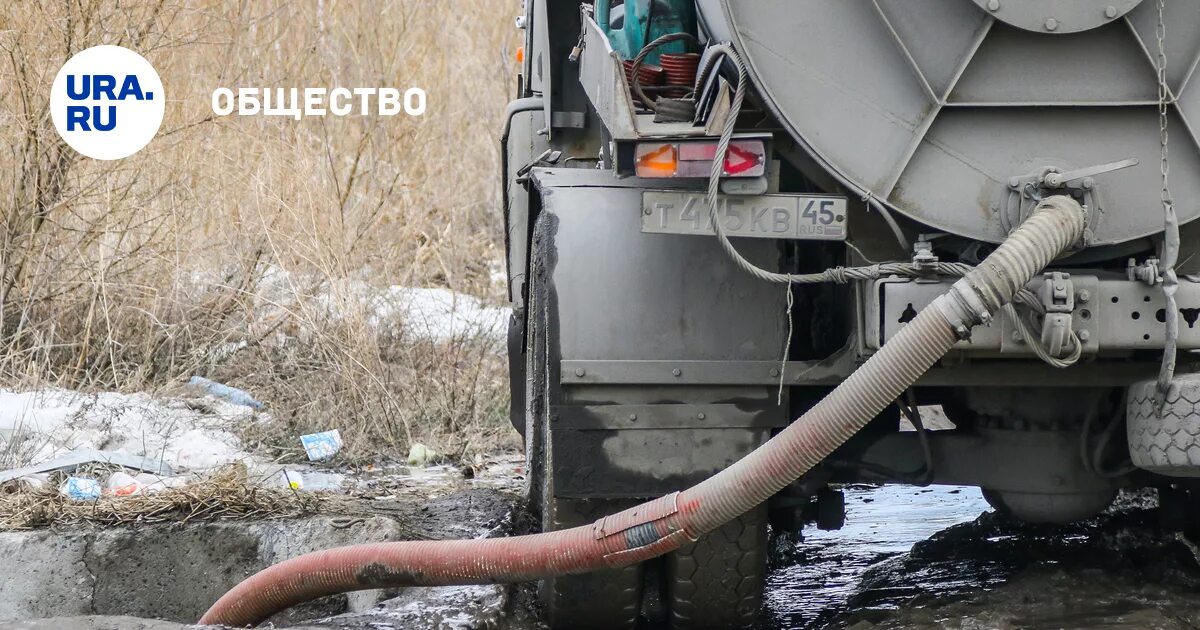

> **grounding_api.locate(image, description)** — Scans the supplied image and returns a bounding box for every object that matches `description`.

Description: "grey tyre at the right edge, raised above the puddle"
[1126,374,1200,476]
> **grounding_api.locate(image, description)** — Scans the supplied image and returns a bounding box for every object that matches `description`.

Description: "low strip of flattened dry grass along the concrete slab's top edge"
[0,467,324,530]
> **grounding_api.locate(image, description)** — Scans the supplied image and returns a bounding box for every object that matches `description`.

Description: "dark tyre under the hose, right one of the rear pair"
[666,505,767,630]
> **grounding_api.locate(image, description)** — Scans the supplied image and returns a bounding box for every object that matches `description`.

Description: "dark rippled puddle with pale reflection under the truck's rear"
[764,486,1200,630]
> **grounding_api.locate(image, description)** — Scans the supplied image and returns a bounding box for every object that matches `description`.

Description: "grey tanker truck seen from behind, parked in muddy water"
[502,0,1200,629]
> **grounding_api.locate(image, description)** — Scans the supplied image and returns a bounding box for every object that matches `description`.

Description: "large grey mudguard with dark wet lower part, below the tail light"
[530,168,788,498]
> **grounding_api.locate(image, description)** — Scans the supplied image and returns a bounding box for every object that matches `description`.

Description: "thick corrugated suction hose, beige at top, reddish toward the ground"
[200,197,1085,626]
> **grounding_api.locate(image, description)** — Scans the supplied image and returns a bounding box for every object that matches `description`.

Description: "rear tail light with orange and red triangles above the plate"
[634,140,767,178]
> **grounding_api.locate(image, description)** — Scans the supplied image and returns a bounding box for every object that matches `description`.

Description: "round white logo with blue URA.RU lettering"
[50,46,166,160]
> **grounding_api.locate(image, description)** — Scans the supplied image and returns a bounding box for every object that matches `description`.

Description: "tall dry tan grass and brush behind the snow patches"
[0,0,517,454]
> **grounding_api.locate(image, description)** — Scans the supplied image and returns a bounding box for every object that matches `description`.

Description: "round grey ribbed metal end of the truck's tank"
[700,0,1200,245]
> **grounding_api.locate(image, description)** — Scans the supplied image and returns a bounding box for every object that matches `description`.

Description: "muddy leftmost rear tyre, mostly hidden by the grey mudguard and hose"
[514,231,643,630]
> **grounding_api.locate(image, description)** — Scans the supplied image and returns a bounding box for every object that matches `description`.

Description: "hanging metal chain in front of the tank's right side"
[1154,0,1180,406]
